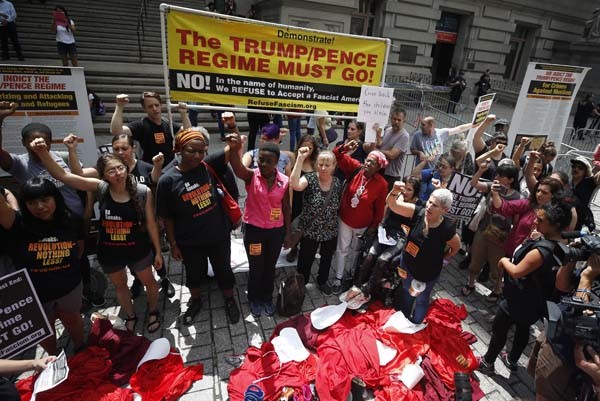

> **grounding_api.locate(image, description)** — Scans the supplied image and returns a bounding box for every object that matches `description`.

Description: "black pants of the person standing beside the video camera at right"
[484,308,531,364]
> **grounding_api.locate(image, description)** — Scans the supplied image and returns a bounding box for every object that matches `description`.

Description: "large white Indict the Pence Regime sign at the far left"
[0,65,98,175]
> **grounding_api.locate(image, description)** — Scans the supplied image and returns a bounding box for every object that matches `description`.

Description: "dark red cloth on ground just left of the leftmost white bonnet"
[88,319,151,386]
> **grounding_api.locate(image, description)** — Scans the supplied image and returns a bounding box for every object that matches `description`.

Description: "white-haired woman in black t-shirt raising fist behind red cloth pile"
[386,188,460,323]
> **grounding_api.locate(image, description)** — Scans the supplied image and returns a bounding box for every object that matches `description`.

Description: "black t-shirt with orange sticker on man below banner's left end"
[127,117,181,164]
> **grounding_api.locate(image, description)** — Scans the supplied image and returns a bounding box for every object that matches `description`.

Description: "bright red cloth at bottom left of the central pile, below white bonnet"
[226,343,317,401]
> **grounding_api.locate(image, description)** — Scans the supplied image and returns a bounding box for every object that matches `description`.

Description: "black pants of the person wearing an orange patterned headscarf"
[178,238,235,291]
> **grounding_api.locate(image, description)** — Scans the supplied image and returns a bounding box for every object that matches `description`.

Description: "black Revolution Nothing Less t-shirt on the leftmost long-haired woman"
[10,212,84,302]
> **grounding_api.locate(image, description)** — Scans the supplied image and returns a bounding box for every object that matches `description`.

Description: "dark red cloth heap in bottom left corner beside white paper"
[17,347,133,401]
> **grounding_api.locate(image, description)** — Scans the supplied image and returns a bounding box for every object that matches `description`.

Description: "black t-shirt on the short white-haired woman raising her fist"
[402,206,456,283]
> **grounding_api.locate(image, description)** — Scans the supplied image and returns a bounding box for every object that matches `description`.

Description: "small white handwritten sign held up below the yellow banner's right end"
[356,85,394,142]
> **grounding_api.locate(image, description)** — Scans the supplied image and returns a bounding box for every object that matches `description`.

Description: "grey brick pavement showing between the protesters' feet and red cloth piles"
[37,248,540,401]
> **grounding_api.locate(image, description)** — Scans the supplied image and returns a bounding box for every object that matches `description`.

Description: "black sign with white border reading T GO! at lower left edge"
[0,269,54,358]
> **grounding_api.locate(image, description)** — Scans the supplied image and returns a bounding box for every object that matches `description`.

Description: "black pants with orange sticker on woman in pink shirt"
[244,224,285,302]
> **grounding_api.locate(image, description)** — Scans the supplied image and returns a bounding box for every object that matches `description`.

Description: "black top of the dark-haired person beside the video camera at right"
[499,240,560,324]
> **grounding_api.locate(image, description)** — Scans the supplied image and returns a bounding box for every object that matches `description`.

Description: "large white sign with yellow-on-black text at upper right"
[507,62,590,156]
